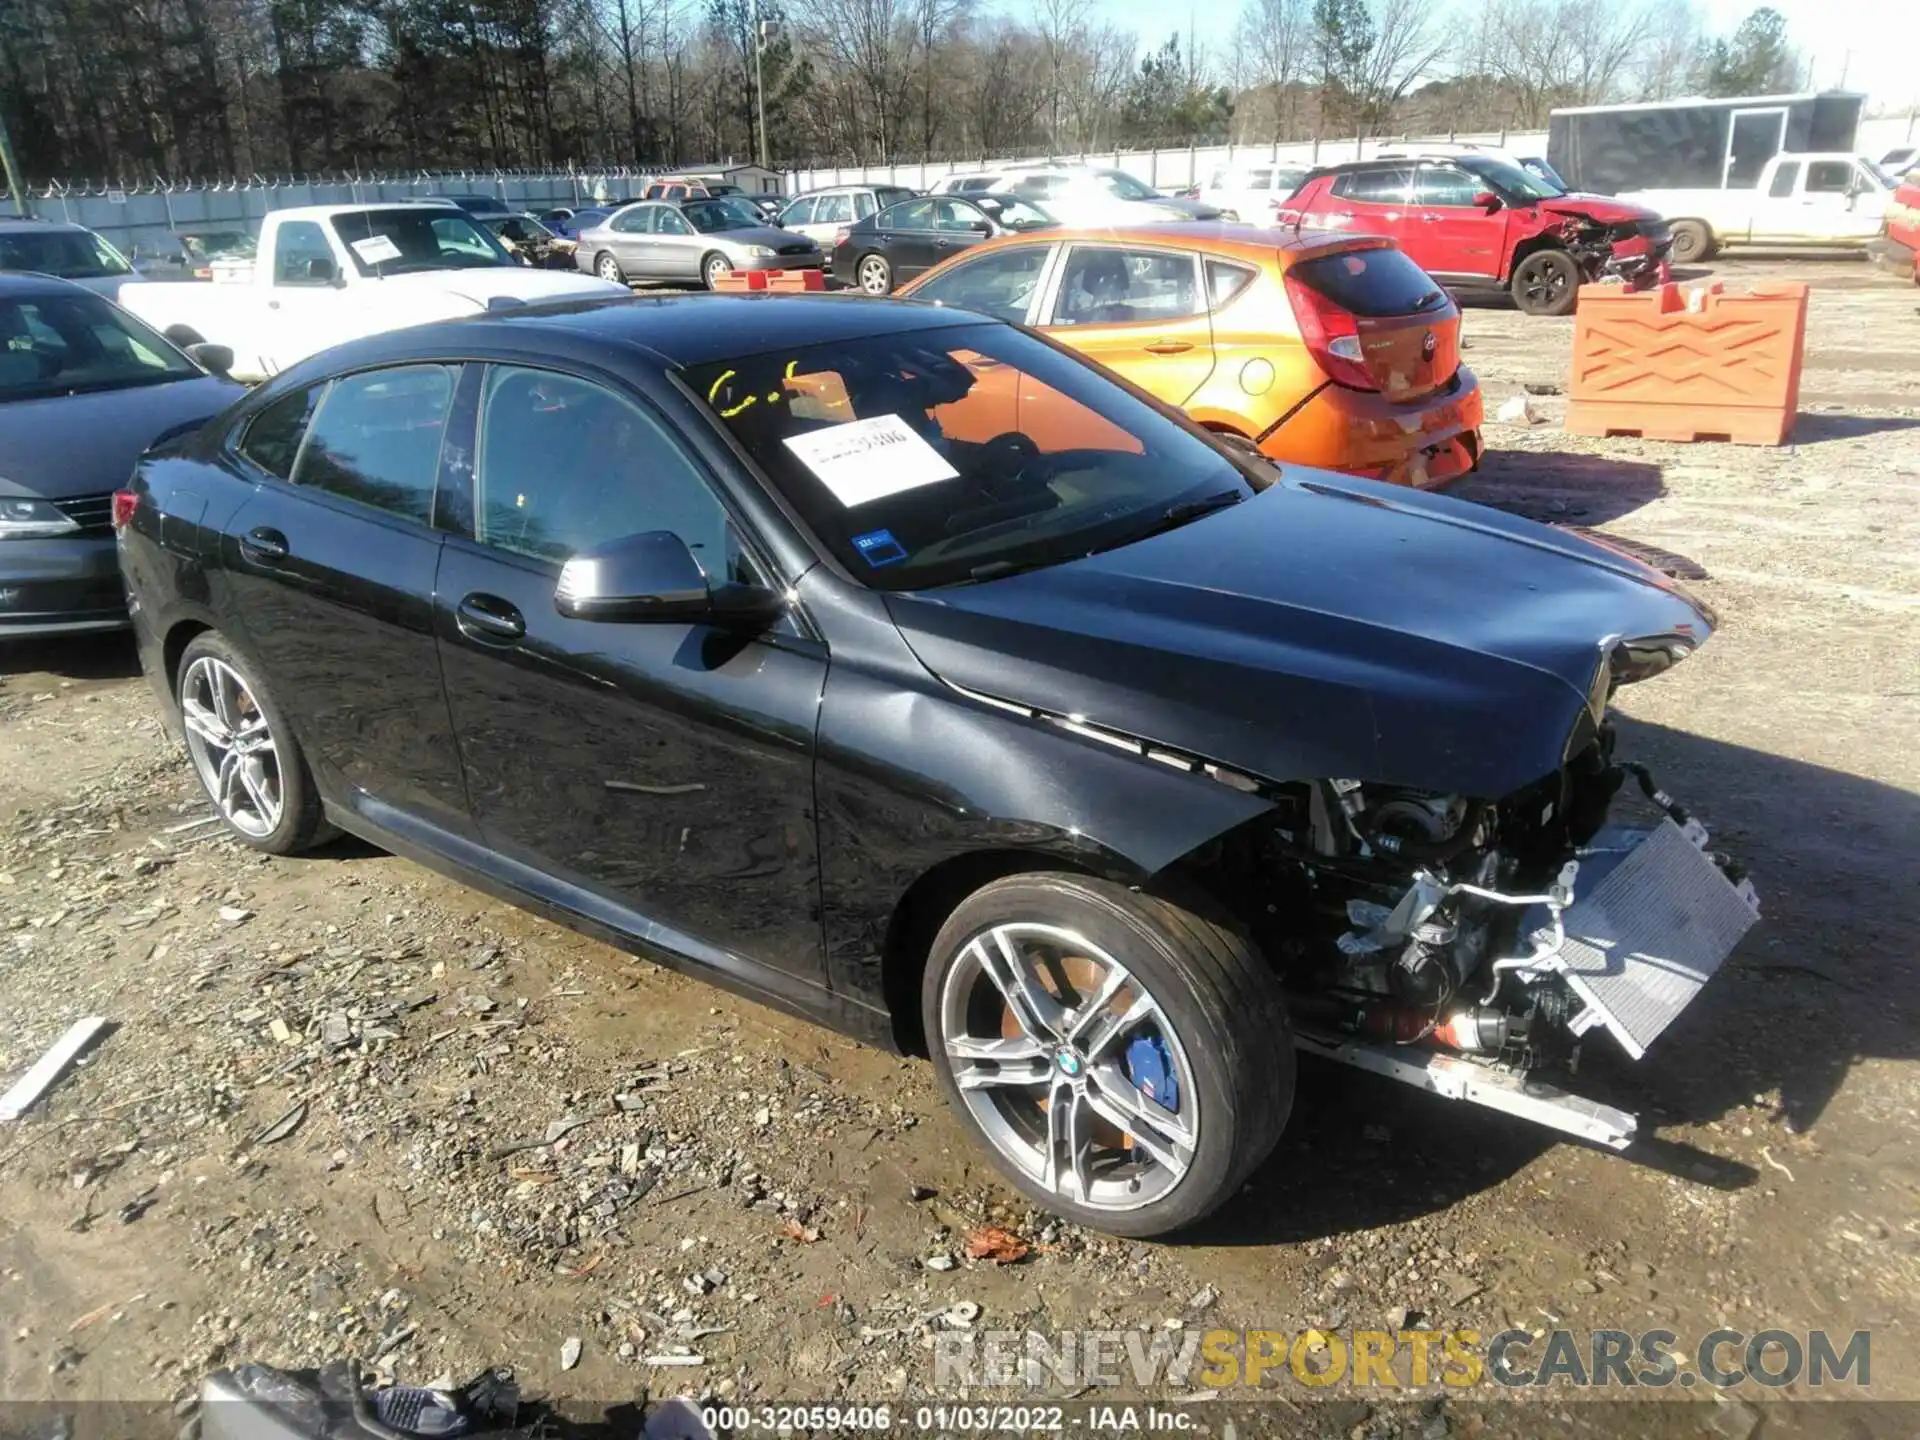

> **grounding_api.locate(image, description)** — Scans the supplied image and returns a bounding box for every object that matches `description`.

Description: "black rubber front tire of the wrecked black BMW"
[920,874,1294,1236]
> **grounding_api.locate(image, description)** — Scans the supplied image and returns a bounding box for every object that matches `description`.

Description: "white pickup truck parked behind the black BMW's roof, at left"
[121,200,626,380]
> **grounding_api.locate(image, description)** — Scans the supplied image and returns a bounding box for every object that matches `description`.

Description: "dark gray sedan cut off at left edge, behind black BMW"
[0,275,246,641]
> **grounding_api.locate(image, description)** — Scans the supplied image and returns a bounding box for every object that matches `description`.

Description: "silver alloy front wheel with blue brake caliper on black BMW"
[937,922,1200,1210]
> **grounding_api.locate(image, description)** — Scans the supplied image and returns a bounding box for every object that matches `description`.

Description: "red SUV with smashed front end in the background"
[1277,156,1672,315]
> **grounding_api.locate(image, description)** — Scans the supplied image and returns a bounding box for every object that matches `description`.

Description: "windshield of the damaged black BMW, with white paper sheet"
[685,324,1260,589]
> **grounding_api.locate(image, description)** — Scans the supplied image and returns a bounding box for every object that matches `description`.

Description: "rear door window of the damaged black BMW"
[289,365,459,524]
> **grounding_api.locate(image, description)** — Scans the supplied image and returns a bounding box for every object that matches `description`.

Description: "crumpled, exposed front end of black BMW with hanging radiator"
[1187,637,1759,1148]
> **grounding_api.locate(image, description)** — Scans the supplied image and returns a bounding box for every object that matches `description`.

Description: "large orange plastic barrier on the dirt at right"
[1567,284,1807,445]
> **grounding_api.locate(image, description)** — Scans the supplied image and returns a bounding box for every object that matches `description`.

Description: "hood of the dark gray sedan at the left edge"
[0,374,246,499]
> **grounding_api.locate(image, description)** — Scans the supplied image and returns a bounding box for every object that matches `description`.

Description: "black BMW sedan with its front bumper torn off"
[117,296,1755,1235]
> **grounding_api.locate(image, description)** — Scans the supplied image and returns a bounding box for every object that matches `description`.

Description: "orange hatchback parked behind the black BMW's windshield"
[899,225,1480,488]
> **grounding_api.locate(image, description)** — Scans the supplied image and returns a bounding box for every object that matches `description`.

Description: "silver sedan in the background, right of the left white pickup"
[574,196,826,290]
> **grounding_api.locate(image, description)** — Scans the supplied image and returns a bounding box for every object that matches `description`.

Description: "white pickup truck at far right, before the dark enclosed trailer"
[1617,152,1893,265]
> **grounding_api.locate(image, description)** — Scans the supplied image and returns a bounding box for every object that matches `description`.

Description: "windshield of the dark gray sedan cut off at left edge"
[0,294,200,401]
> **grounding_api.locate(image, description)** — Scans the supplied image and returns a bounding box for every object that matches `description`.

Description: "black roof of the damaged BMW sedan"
[300,294,991,372]
